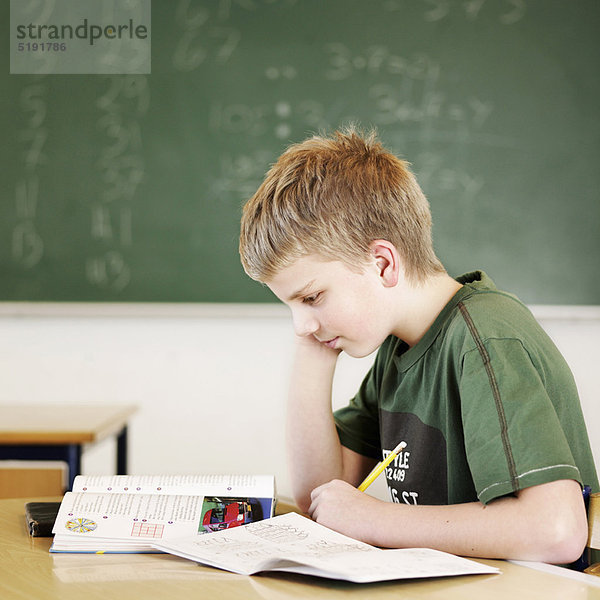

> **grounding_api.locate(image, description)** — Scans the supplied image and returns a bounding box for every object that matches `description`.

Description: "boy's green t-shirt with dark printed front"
[335,271,598,504]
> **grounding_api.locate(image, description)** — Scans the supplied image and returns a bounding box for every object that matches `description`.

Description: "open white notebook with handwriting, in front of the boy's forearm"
[153,513,498,583]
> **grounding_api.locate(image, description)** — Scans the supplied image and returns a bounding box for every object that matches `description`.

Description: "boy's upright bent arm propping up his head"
[286,336,376,512]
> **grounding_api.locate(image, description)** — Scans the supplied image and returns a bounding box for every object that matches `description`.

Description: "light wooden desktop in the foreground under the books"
[0,499,600,600]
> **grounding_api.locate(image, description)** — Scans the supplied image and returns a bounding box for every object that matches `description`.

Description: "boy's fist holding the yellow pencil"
[308,479,385,543]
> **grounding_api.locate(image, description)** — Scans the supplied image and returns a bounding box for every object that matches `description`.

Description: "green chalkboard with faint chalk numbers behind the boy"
[0,0,600,304]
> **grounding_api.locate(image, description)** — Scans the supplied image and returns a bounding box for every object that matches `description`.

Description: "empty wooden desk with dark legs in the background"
[0,404,136,489]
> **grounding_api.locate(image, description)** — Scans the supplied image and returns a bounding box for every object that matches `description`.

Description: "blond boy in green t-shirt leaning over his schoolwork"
[240,129,598,563]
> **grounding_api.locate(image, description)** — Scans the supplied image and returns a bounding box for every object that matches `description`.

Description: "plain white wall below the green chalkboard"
[0,304,600,496]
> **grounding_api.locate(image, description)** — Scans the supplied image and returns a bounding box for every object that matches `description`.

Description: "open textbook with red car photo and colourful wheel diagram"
[50,475,275,552]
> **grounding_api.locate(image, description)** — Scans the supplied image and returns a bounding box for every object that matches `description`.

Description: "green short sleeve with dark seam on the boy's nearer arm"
[460,338,581,503]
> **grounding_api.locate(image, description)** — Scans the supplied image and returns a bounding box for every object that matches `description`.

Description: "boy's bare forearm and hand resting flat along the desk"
[309,480,587,564]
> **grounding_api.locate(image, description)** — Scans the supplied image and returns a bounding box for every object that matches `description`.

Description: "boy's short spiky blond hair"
[240,127,444,282]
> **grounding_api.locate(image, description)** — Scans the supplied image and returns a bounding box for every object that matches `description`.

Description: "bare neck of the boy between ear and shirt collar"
[392,273,462,347]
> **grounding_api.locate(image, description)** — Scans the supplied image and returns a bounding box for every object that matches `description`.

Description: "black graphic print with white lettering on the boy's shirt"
[380,410,448,504]
